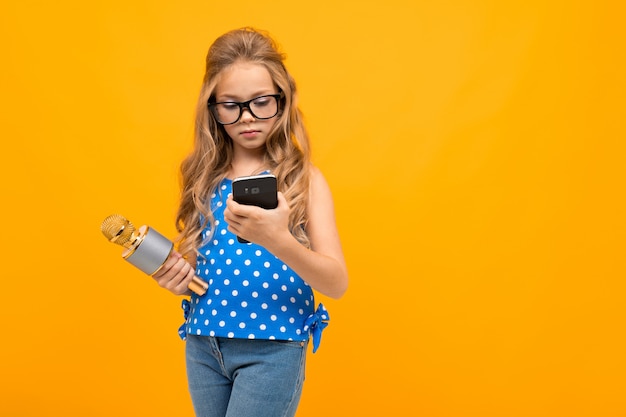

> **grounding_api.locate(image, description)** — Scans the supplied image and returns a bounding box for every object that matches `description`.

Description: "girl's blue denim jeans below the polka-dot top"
[186,335,308,417]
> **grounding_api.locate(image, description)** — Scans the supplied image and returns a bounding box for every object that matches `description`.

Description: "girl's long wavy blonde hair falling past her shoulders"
[176,28,310,255]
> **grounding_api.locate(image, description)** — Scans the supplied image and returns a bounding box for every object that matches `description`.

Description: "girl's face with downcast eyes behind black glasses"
[215,62,278,154]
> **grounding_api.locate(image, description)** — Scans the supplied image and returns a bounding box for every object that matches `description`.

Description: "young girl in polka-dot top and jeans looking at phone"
[154,28,348,417]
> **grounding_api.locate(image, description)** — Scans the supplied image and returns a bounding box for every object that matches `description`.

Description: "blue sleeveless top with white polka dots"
[179,178,329,351]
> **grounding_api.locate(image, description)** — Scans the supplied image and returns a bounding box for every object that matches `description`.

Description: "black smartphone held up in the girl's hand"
[233,174,278,243]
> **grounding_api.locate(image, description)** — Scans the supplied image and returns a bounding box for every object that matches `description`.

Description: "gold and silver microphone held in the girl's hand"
[100,214,209,295]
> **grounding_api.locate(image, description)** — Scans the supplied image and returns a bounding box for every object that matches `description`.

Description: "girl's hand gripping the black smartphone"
[224,191,291,249]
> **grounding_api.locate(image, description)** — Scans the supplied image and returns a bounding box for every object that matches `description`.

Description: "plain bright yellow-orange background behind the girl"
[0,0,626,417]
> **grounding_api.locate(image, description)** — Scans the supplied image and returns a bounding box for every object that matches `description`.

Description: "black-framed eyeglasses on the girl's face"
[207,93,283,125]
